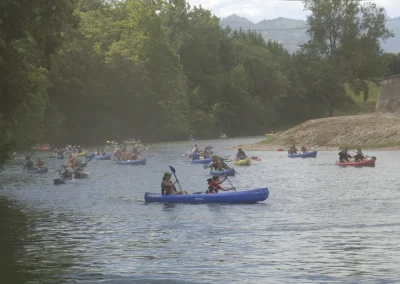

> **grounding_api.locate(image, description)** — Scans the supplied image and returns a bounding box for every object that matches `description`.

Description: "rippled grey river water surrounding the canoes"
[0,138,400,284]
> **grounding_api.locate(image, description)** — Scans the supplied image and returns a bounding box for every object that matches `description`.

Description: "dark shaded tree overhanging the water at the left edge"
[0,0,76,151]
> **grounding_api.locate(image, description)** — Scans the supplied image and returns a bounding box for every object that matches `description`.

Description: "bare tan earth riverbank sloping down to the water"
[236,114,400,151]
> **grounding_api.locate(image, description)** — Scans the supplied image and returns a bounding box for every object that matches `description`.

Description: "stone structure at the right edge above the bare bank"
[376,75,400,114]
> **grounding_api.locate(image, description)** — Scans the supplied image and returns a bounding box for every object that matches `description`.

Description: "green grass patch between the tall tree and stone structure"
[335,83,379,116]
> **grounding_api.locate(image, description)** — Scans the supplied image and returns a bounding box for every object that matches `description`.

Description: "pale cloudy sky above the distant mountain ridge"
[188,0,400,22]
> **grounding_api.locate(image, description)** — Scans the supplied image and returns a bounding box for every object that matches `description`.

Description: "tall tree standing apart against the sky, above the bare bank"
[302,0,393,116]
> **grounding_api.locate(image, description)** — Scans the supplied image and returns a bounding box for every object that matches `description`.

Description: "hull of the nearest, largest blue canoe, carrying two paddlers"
[144,188,269,204]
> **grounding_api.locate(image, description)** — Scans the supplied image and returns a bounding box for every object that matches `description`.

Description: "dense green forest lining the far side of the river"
[0,0,400,164]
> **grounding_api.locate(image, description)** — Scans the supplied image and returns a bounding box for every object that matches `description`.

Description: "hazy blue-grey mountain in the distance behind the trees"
[221,14,400,53]
